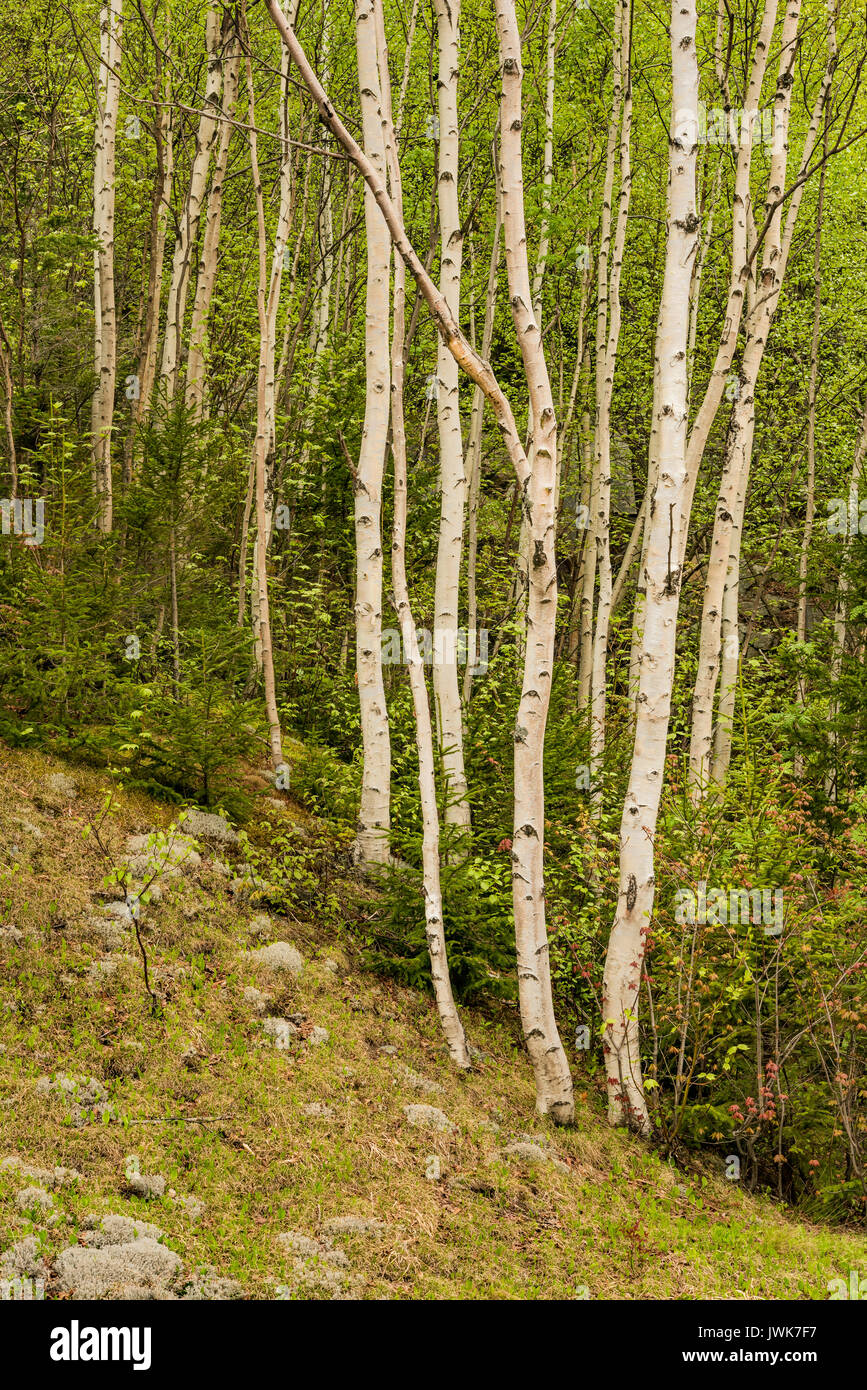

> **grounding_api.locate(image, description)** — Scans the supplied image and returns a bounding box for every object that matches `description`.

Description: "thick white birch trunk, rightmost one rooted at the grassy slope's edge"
[602,0,700,1133]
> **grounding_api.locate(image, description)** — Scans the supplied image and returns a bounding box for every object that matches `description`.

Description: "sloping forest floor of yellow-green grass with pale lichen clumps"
[0,748,867,1300]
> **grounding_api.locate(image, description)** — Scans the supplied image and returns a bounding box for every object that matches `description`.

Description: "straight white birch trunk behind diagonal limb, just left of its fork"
[434,0,470,831]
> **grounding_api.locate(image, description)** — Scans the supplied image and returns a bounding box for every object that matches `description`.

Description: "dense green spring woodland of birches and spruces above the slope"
[0,0,867,1222]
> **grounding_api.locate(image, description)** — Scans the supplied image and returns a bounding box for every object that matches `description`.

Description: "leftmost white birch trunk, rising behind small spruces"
[90,0,124,532]
